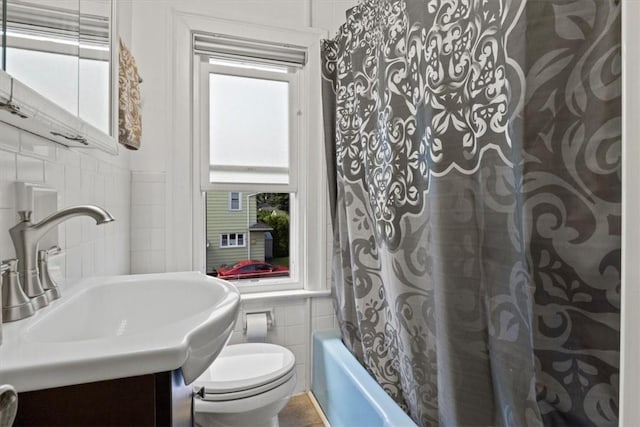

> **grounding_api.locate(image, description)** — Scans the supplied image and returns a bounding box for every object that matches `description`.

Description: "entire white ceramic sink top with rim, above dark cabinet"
[0,272,240,391]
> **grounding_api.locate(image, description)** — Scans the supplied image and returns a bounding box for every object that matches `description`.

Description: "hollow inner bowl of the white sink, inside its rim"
[26,276,229,342]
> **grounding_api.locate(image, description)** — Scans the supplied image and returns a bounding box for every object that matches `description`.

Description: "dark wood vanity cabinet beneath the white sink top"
[14,370,193,427]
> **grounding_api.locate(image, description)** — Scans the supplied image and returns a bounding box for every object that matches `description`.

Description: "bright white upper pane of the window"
[209,73,289,184]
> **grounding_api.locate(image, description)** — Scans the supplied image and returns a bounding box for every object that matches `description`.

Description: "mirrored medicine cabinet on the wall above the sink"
[0,0,117,152]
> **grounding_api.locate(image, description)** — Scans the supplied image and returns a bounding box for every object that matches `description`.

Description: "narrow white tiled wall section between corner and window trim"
[131,171,166,274]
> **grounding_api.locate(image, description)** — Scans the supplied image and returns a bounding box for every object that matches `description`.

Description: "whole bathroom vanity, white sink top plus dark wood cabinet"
[0,272,240,426]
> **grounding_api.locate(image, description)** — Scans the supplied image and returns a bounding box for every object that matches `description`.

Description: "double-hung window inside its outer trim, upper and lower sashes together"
[196,36,304,290]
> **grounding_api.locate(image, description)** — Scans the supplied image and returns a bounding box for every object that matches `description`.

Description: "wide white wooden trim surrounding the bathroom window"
[174,10,328,297]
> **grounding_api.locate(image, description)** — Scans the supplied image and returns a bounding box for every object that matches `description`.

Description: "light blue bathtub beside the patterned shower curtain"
[311,331,416,427]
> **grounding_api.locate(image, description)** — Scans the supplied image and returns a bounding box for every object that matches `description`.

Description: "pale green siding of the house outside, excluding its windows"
[206,192,264,272]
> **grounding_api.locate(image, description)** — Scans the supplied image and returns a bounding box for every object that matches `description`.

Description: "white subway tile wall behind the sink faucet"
[0,123,131,279]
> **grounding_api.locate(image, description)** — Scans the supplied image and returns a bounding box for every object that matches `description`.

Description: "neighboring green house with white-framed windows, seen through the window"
[206,192,273,272]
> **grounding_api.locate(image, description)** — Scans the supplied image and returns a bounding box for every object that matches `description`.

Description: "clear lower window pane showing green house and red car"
[206,191,293,281]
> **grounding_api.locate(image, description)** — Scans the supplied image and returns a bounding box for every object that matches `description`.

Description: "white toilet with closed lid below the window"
[193,343,296,427]
